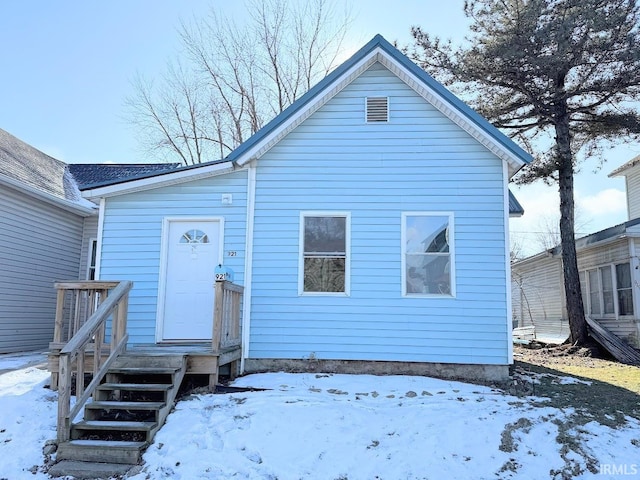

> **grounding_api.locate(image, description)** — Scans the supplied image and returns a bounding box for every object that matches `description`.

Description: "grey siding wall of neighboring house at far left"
[0,186,83,353]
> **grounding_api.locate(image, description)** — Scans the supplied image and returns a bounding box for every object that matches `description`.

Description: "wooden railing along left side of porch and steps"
[50,281,133,442]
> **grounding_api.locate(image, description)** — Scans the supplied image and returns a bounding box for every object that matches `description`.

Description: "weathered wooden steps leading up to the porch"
[57,355,187,465]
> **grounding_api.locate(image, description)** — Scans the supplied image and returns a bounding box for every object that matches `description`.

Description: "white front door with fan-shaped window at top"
[160,220,221,341]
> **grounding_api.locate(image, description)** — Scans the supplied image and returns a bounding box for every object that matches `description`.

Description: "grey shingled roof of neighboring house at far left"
[0,128,92,214]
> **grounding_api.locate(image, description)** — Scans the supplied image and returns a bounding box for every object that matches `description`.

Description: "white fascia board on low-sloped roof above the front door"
[82,162,234,199]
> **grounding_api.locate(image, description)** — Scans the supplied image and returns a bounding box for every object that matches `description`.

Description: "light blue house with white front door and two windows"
[83,36,531,379]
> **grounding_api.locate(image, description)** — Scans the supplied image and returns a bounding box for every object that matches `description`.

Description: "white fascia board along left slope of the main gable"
[237,48,381,166]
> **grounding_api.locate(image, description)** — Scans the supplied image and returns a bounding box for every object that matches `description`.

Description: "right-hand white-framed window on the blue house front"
[402,213,455,296]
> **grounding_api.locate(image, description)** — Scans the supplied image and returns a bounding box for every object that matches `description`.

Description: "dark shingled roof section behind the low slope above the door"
[69,163,180,190]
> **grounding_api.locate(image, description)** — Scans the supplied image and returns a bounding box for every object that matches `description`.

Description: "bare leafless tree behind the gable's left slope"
[126,0,350,165]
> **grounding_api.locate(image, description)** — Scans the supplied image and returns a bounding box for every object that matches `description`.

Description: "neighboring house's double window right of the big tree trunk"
[580,263,633,316]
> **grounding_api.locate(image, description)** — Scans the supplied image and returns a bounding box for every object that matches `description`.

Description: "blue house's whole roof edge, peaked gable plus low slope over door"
[85,35,532,199]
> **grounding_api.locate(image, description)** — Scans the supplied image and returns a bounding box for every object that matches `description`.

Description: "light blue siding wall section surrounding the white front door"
[100,170,247,344]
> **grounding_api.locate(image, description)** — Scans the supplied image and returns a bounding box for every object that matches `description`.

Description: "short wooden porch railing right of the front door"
[212,280,244,352]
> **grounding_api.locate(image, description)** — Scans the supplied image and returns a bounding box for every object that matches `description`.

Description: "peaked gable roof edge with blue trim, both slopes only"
[226,35,532,177]
